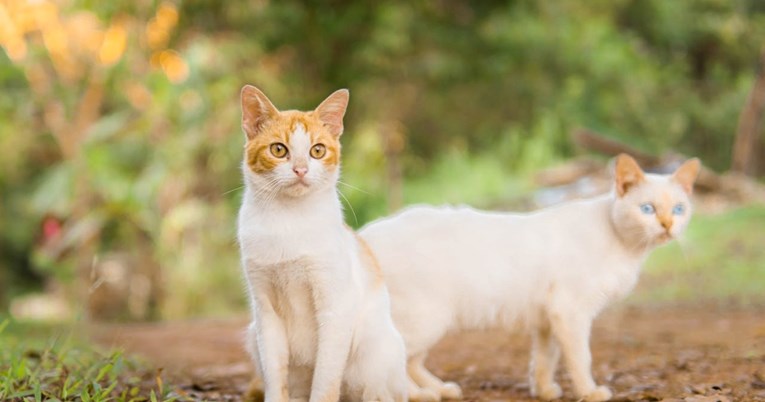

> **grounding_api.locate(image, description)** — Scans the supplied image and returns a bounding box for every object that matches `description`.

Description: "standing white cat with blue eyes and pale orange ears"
[359,155,700,401]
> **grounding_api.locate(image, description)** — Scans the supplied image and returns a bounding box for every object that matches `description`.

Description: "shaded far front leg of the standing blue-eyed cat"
[529,323,563,401]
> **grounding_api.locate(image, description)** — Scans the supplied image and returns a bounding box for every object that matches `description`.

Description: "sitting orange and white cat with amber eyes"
[238,85,407,402]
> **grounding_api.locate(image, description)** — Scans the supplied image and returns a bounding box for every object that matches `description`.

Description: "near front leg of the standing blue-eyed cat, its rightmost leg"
[550,303,612,402]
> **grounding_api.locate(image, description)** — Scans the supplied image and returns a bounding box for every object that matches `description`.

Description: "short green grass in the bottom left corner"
[0,315,182,402]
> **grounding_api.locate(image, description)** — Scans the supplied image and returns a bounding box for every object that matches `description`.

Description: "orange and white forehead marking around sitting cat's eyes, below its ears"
[246,110,340,174]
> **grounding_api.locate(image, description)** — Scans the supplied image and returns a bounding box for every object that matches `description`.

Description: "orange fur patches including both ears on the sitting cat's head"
[242,86,348,174]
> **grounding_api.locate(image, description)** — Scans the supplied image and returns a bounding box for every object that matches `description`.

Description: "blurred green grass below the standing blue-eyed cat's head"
[632,205,765,305]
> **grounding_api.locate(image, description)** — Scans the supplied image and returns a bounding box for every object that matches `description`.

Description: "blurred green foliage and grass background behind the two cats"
[0,0,765,320]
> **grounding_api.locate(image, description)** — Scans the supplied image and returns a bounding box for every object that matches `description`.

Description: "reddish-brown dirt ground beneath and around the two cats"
[90,307,765,402]
